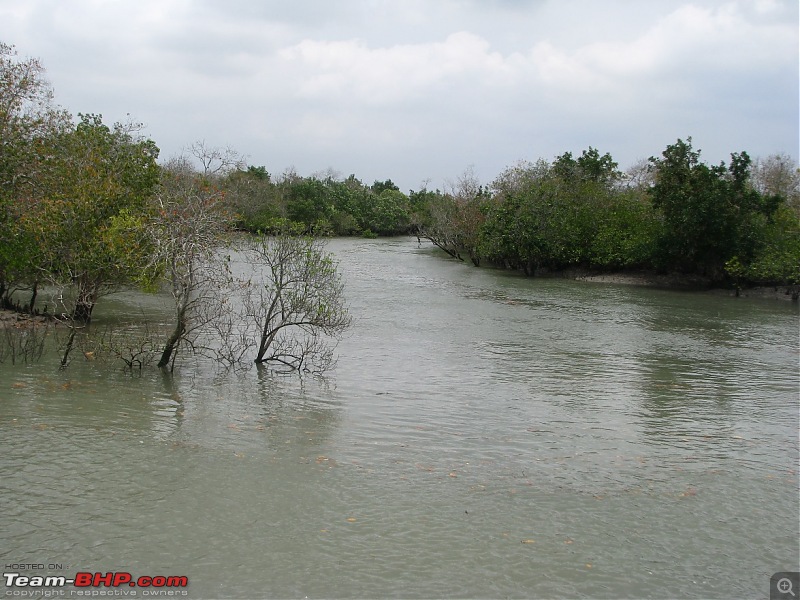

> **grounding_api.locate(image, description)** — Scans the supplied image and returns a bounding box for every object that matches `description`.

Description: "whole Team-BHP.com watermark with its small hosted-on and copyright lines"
[2,562,190,598]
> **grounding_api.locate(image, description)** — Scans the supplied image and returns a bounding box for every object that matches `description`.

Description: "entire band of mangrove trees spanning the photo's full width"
[0,38,800,342]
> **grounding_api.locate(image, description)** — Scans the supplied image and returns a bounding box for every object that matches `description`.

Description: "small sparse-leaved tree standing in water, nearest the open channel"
[244,234,351,372]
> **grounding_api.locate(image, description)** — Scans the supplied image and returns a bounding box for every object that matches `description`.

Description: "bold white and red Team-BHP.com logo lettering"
[3,571,189,596]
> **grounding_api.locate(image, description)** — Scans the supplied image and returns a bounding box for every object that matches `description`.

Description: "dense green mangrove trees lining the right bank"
[420,143,800,286]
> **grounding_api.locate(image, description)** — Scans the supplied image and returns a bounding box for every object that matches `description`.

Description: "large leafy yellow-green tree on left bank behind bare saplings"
[40,115,159,303]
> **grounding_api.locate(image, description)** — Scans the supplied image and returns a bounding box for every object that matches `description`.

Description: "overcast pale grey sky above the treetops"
[0,0,800,191]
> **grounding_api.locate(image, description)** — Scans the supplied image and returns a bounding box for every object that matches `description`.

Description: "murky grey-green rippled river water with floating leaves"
[0,239,800,598]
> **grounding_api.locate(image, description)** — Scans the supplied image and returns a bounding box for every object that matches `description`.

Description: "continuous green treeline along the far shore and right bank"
[222,143,800,285]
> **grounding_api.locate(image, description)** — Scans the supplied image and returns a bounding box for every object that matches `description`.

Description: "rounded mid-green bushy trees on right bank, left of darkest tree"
[482,148,640,274]
